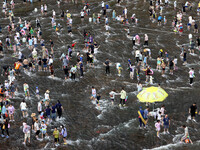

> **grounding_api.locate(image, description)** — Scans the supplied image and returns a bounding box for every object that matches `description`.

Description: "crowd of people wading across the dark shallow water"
[0,0,200,146]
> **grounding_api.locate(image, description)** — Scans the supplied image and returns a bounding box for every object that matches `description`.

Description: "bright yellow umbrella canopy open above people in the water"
[137,86,168,103]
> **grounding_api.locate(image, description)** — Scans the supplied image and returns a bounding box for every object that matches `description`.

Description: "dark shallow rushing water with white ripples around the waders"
[0,0,200,150]
